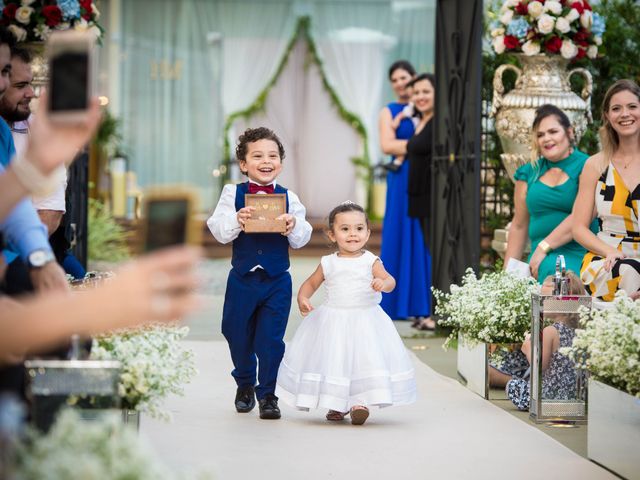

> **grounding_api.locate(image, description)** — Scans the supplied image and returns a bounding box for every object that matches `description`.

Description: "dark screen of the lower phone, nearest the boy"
[144,199,189,252]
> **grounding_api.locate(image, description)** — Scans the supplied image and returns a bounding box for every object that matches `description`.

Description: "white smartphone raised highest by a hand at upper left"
[46,30,95,123]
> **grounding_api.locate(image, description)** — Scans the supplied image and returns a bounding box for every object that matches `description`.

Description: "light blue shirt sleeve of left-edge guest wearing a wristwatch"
[0,142,51,262]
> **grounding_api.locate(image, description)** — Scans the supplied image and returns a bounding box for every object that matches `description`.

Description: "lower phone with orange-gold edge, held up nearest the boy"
[142,187,201,252]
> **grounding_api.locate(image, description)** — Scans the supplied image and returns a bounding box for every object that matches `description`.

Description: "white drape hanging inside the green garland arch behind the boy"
[236,38,365,219]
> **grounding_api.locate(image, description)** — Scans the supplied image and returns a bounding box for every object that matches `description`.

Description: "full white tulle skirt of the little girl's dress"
[276,305,416,412]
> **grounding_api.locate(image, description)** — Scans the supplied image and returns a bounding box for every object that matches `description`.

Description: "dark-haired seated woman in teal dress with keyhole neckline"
[504,104,597,282]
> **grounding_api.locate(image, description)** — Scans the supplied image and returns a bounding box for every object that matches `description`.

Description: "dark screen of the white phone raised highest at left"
[49,51,89,112]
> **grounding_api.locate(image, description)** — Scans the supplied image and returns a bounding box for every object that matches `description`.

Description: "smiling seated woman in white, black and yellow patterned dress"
[573,80,640,301]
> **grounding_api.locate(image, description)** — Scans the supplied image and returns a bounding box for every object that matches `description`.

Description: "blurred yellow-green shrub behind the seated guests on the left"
[87,198,130,262]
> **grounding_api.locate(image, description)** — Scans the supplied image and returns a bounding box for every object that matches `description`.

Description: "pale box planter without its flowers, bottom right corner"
[587,378,640,480]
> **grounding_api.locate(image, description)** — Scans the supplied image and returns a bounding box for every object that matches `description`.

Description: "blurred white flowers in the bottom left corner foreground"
[14,409,173,480]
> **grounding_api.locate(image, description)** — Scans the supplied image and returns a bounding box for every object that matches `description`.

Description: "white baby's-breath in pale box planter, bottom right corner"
[566,295,640,479]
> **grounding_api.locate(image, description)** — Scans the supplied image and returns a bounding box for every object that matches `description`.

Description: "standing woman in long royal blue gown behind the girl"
[379,60,434,330]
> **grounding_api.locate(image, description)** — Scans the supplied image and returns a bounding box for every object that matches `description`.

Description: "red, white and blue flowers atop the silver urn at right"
[491,0,605,60]
